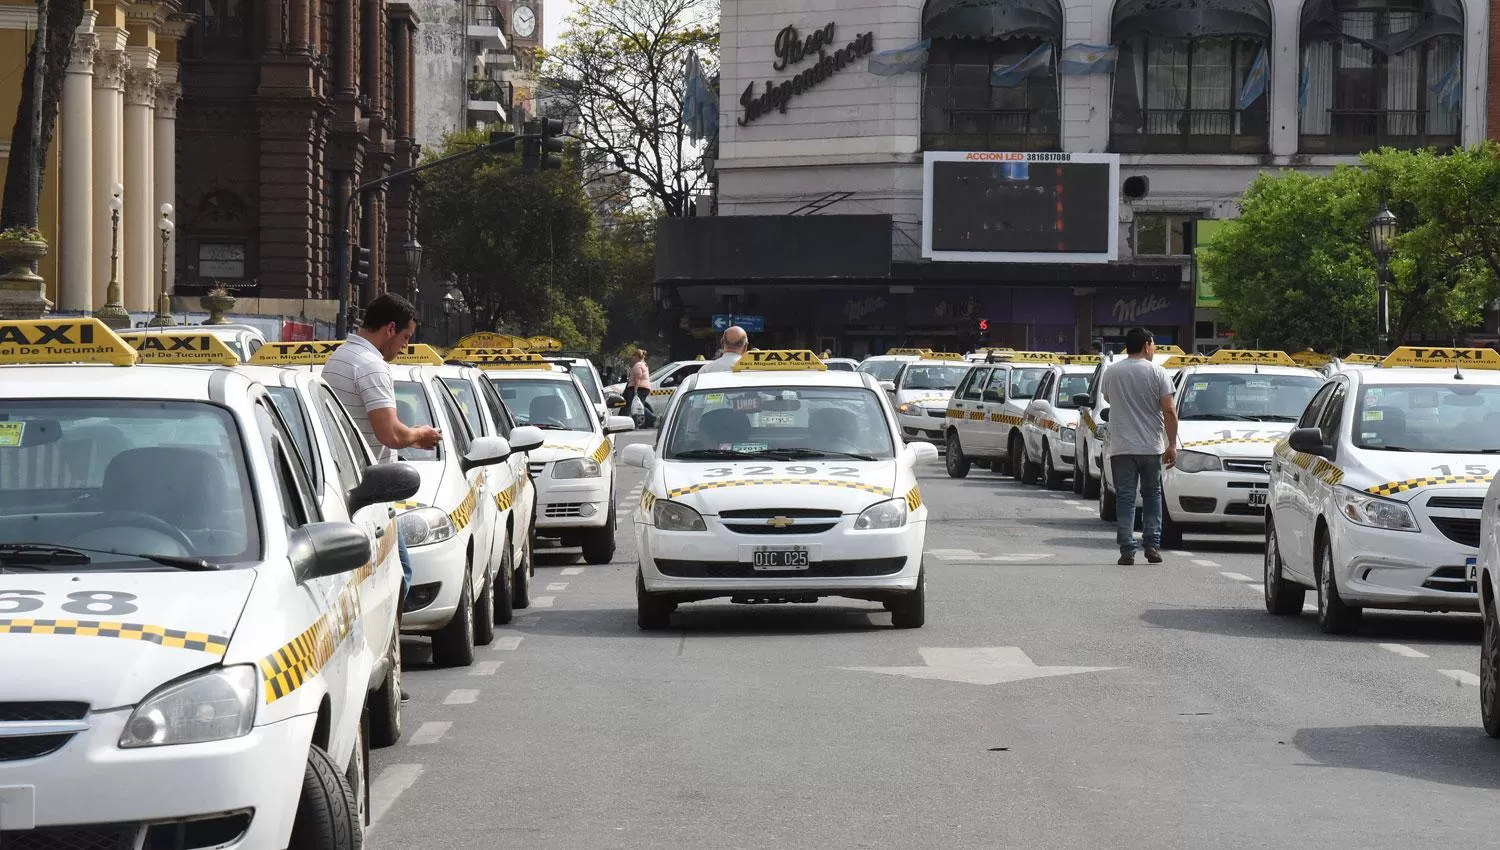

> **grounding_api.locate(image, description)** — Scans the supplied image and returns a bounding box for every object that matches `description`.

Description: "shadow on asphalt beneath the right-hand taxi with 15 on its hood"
[1140,600,1484,646]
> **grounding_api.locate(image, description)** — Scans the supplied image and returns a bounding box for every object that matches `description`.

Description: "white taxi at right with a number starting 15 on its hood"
[1265,348,1500,634]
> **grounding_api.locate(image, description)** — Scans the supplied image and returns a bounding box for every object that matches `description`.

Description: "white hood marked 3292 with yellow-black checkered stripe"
[653,460,905,514]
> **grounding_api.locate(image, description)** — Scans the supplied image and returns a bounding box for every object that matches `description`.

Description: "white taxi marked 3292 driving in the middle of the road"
[621,351,938,630]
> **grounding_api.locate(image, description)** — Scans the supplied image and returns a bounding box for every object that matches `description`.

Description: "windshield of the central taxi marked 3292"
[663,387,896,460]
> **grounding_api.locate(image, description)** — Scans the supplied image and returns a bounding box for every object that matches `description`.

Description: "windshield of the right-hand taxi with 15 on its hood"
[1355,381,1500,454]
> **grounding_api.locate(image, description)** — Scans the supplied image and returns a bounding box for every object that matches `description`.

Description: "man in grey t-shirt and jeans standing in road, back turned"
[1100,328,1178,567]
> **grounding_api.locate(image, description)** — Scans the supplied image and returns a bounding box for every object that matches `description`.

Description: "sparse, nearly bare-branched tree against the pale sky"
[543,0,719,216]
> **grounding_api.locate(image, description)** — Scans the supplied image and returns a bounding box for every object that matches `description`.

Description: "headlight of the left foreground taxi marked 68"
[120,664,258,750]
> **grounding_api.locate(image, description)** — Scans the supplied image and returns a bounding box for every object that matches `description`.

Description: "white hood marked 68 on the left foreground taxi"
[0,570,257,711]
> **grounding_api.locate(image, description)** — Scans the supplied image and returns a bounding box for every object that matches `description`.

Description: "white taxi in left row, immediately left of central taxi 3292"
[480,352,635,564]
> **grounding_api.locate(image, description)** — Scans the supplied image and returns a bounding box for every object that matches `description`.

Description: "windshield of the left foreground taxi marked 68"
[0,399,261,570]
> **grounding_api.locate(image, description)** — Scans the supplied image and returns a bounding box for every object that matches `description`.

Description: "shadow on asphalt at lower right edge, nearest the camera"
[1292,726,1500,789]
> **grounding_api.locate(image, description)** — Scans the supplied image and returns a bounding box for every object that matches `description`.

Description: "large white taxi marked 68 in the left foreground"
[0,318,416,850]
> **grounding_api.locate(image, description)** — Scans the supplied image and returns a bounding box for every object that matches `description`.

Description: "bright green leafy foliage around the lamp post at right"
[1203,142,1500,352]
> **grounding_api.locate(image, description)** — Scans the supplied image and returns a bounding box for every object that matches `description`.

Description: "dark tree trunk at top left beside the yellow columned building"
[0,0,84,231]
